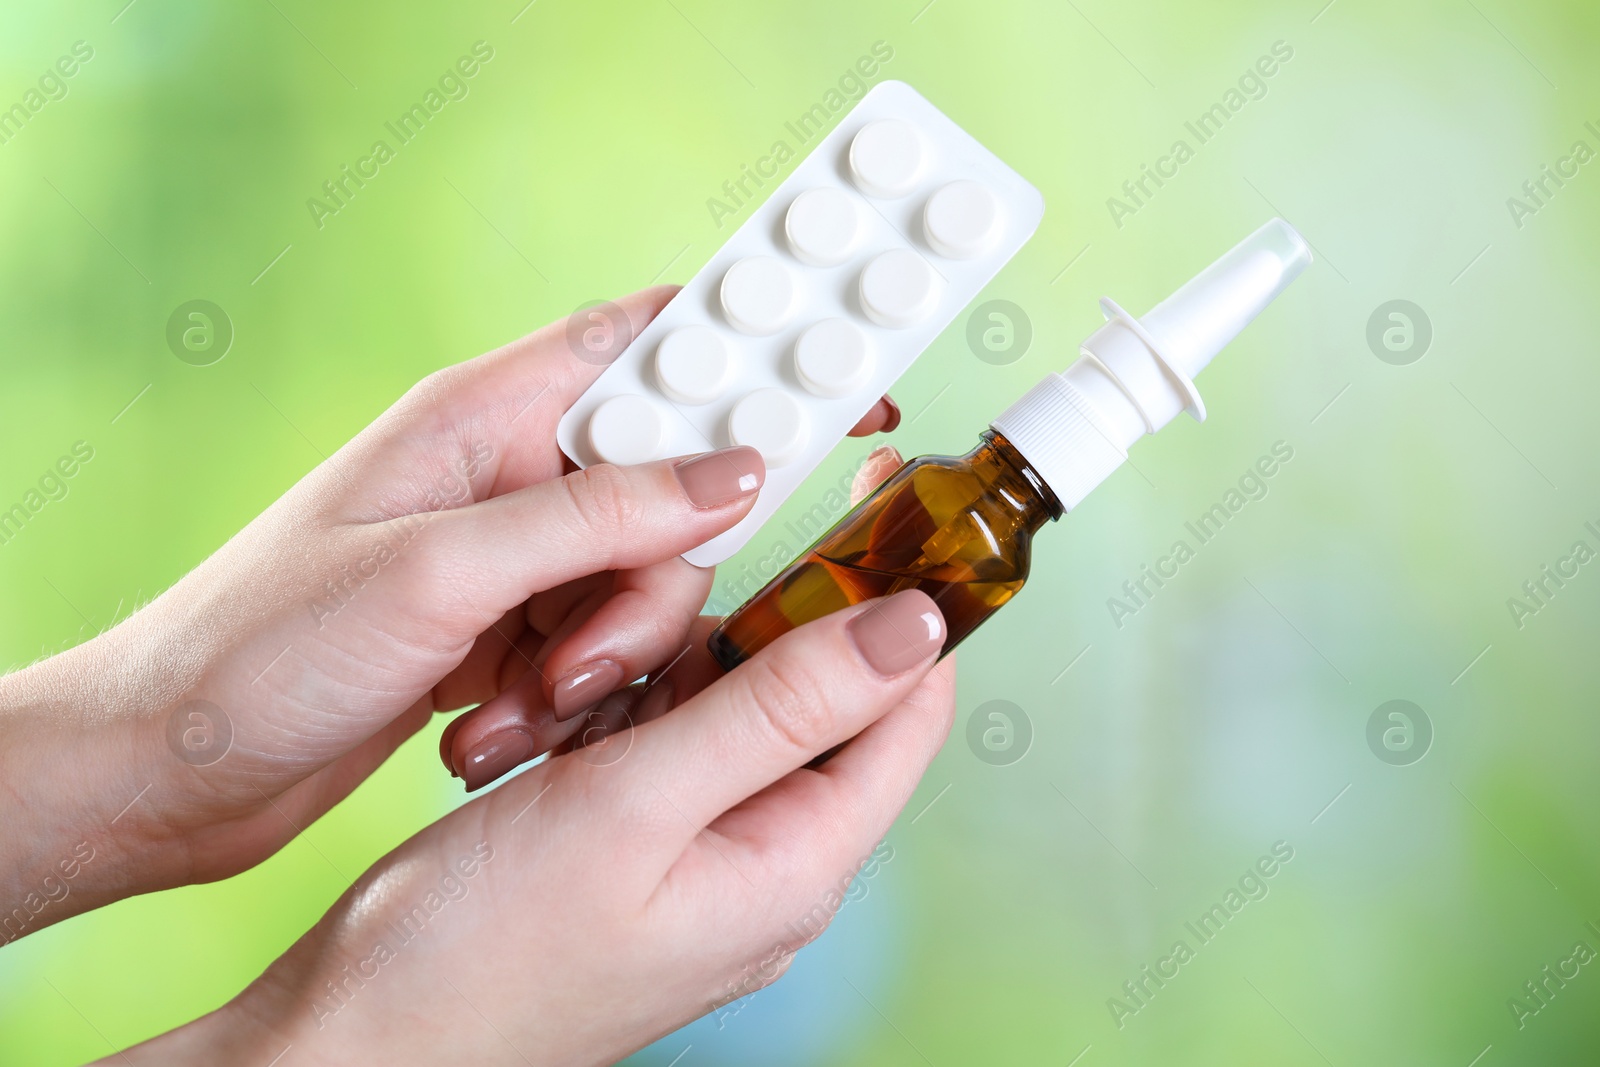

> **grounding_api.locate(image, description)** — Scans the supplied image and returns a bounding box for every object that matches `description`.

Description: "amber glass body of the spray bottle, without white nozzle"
[709,430,1061,670]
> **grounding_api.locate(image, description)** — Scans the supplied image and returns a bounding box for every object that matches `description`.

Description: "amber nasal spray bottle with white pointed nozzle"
[710,219,1310,670]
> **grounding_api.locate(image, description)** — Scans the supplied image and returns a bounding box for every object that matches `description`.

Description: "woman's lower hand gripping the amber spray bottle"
[128,590,954,1065]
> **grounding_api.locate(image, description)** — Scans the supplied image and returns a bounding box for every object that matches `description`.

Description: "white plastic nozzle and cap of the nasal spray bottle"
[990,219,1310,510]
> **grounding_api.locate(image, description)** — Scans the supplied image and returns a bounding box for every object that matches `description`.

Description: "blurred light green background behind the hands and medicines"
[0,0,1600,1067]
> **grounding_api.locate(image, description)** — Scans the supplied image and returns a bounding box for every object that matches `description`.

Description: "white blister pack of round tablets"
[557,82,1045,566]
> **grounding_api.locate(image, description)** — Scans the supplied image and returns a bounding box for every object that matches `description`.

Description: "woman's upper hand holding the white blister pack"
[0,288,898,939]
